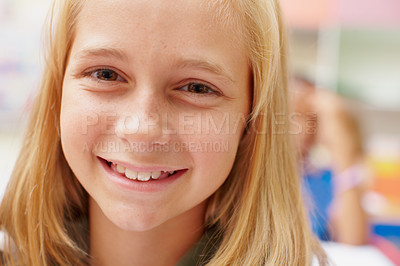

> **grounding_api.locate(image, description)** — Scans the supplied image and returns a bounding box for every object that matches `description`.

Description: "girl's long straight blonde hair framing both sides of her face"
[0,0,324,265]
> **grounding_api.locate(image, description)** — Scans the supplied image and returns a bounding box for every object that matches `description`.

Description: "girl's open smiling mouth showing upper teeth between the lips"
[102,159,187,182]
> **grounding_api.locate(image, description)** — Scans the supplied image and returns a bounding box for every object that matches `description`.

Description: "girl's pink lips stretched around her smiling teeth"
[97,157,188,193]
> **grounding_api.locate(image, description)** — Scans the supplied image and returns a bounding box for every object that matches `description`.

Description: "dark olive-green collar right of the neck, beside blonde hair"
[176,226,221,266]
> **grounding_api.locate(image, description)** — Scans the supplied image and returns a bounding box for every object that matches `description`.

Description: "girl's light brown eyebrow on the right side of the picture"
[176,59,236,83]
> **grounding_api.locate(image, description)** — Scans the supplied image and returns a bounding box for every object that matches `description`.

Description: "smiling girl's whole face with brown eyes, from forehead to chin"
[61,0,251,231]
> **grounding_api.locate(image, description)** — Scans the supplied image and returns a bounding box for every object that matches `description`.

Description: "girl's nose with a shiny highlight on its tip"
[115,91,169,148]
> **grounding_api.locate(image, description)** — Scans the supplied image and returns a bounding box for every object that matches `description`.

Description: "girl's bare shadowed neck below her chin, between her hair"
[89,199,206,266]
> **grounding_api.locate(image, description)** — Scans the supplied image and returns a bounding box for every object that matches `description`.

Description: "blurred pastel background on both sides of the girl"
[0,0,400,264]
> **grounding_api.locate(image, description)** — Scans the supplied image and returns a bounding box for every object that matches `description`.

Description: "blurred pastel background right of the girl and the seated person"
[281,0,400,265]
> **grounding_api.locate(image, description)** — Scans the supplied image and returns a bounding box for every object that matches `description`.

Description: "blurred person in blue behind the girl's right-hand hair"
[291,77,369,245]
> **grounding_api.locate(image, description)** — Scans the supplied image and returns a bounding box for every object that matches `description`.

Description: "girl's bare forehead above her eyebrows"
[77,0,241,49]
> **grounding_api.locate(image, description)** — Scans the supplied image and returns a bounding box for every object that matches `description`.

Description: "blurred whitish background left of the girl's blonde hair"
[0,0,50,197]
